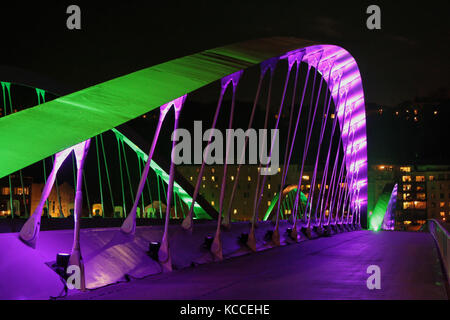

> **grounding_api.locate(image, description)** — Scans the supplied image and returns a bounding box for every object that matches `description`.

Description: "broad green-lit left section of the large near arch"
[0,37,313,178]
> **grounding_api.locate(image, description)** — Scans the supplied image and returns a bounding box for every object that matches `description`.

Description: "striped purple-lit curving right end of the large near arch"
[281,45,367,226]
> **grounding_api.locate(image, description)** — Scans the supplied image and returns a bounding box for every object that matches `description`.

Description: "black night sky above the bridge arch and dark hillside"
[0,0,450,105]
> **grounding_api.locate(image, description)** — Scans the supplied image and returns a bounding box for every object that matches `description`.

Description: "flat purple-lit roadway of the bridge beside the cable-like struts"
[68,231,448,299]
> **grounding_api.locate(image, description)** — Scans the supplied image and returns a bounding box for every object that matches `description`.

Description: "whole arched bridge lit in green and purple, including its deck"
[0,38,448,299]
